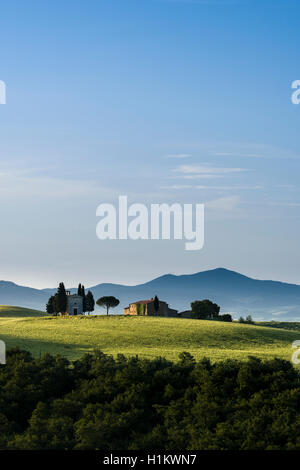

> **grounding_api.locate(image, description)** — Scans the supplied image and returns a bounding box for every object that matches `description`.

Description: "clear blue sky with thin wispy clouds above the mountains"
[0,0,300,287]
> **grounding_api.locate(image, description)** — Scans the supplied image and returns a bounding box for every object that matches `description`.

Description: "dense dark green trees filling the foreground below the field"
[0,349,300,450]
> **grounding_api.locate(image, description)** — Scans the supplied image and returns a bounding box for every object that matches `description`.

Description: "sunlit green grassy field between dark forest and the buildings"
[0,306,300,361]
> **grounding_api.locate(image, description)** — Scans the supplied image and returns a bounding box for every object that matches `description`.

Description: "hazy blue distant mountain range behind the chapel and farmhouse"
[0,268,300,321]
